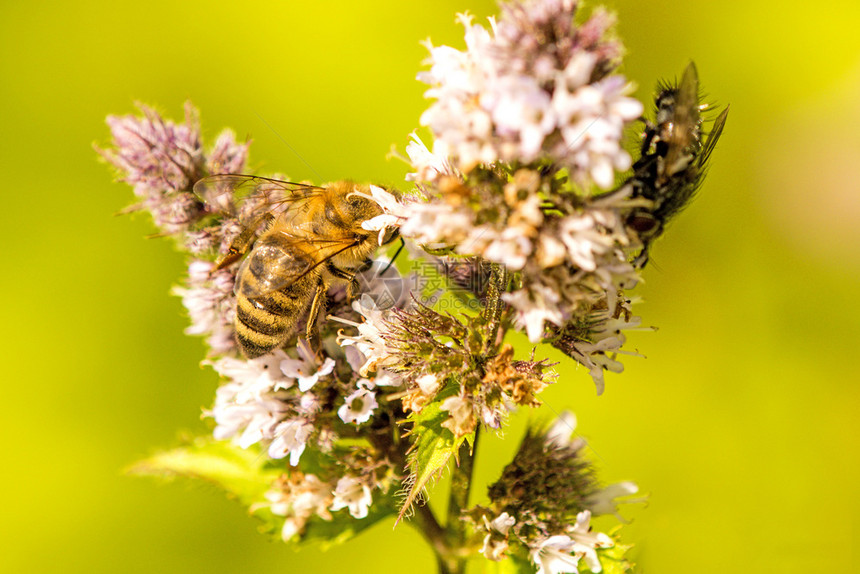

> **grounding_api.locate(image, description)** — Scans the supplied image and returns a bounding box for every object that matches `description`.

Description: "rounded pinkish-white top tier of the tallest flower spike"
[418,0,642,188]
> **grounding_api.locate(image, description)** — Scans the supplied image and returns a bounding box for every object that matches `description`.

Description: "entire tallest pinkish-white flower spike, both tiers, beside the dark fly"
[386,0,656,391]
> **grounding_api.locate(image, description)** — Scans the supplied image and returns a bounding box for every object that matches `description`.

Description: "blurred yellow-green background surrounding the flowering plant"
[0,0,860,574]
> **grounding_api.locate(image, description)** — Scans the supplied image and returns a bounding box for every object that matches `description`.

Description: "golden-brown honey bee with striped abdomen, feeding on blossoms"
[194,175,399,359]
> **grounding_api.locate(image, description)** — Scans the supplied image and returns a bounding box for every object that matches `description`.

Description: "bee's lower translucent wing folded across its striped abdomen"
[236,232,357,299]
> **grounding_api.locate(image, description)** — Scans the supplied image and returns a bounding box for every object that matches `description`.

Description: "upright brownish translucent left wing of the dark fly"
[665,62,700,176]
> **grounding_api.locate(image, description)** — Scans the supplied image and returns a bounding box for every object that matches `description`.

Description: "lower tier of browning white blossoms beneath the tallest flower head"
[390,155,640,391]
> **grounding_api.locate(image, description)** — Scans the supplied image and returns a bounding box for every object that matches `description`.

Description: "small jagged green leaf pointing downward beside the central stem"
[397,385,468,522]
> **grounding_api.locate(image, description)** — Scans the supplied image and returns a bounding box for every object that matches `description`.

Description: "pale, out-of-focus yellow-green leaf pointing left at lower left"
[127,437,282,506]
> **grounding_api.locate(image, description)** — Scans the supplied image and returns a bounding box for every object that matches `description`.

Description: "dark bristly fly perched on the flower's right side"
[609,62,729,269]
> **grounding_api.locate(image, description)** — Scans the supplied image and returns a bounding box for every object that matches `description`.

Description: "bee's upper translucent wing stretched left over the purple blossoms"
[194,173,323,219]
